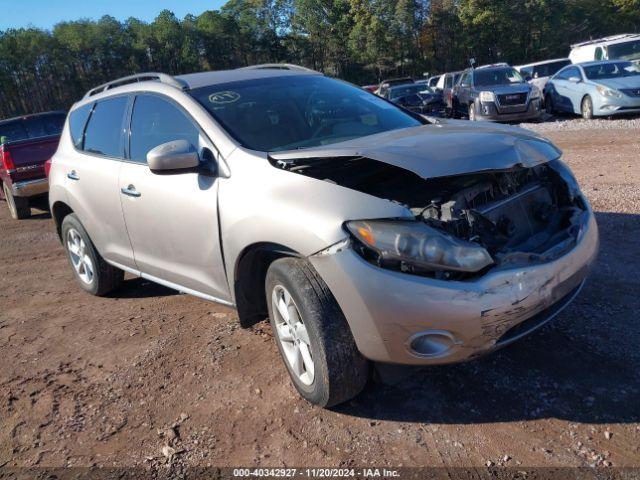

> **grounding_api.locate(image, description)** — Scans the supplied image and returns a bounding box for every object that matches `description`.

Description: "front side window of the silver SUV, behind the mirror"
[130,95,200,163]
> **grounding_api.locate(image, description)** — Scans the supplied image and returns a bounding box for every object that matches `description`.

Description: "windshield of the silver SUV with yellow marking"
[191,75,423,152]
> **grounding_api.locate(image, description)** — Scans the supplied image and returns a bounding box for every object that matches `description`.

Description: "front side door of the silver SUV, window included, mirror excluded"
[119,94,229,300]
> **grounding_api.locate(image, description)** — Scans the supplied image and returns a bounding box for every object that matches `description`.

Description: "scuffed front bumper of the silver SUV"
[309,206,598,365]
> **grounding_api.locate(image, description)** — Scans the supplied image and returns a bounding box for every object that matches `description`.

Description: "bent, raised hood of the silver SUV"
[269,120,562,179]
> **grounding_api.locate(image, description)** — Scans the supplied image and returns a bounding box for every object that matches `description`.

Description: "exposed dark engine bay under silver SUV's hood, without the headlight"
[272,157,587,278]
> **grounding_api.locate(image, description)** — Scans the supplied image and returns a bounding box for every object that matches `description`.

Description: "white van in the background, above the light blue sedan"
[569,33,640,63]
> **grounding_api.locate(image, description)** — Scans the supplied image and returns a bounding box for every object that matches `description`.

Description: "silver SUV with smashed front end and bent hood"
[50,66,598,406]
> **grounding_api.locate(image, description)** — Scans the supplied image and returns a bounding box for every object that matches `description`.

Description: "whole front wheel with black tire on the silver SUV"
[265,258,369,407]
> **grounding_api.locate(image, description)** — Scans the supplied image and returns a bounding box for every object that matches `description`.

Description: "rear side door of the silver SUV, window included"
[61,96,134,268]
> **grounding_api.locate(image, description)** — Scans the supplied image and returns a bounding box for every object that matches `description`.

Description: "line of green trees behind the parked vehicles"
[0,0,640,118]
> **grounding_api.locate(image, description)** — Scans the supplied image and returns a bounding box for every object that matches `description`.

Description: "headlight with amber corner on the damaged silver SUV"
[346,220,493,273]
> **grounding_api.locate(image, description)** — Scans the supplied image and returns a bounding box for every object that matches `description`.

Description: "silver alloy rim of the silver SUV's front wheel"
[271,285,315,385]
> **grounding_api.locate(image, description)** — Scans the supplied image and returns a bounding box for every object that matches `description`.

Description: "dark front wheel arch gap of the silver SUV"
[232,242,303,328]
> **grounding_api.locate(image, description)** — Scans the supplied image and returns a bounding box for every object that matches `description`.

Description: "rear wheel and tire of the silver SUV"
[61,213,124,296]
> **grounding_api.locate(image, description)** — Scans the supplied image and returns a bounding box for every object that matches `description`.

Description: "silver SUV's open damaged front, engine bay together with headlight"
[272,156,589,280]
